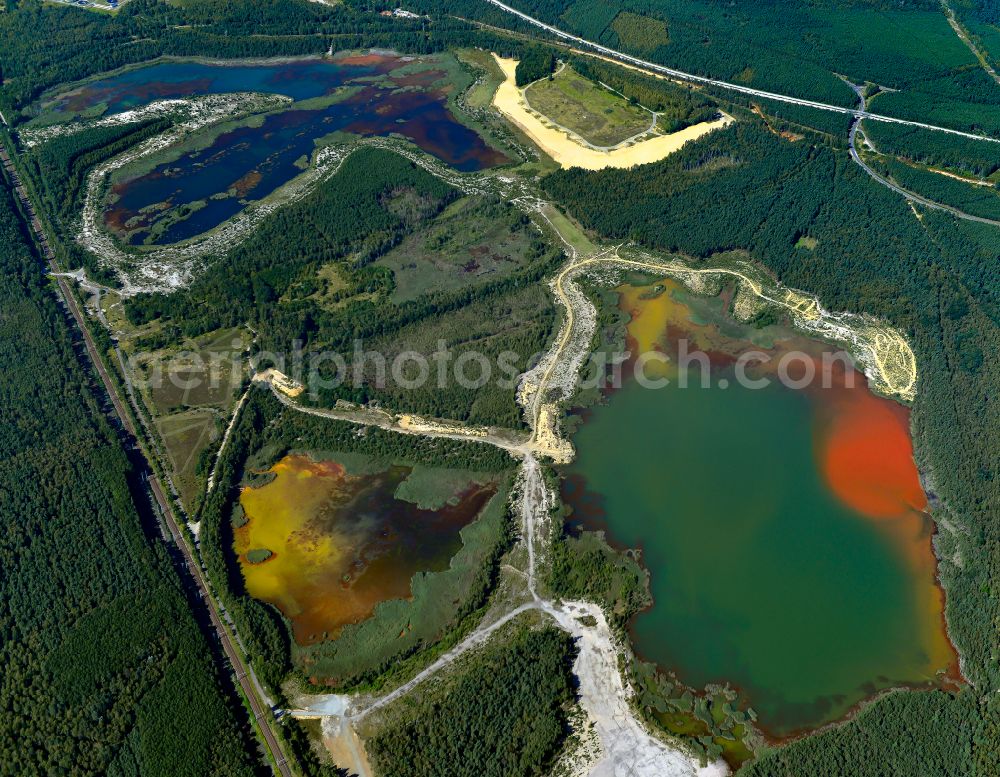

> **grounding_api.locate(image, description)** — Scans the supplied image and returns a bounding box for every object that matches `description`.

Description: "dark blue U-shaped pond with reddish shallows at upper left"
[43,54,509,245]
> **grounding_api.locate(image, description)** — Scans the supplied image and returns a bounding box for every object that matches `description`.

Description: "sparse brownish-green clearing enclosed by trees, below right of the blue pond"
[377,197,538,303]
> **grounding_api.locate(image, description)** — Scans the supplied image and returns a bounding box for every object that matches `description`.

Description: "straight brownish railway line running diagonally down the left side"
[0,146,293,777]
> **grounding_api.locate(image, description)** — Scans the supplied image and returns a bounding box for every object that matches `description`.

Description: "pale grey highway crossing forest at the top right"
[484,0,1000,143]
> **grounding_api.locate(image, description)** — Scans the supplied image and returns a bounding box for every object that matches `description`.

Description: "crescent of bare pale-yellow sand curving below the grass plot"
[493,54,733,170]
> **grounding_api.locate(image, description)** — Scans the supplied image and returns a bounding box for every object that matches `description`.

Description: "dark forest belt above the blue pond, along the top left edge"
[0,0,548,122]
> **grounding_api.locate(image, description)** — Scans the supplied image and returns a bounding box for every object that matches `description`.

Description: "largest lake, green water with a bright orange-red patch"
[563,280,957,740]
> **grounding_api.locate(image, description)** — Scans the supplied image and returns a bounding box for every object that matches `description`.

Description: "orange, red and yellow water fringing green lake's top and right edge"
[619,280,961,686]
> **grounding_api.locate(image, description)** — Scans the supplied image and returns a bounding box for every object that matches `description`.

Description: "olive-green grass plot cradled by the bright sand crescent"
[524,66,653,147]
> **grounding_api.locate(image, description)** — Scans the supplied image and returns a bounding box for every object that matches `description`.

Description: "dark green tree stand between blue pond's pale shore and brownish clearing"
[126,148,459,338]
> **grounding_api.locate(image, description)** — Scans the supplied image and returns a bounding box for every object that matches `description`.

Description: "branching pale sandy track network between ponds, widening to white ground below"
[284,168,916,777]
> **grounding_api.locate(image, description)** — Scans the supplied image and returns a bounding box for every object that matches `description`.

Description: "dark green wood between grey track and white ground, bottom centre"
[366,628,573,777]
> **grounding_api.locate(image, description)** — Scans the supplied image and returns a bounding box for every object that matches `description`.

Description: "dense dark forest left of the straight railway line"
[0,155,262,777]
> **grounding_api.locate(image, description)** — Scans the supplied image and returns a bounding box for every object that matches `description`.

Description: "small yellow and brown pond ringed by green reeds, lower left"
[234,454,497,646]
